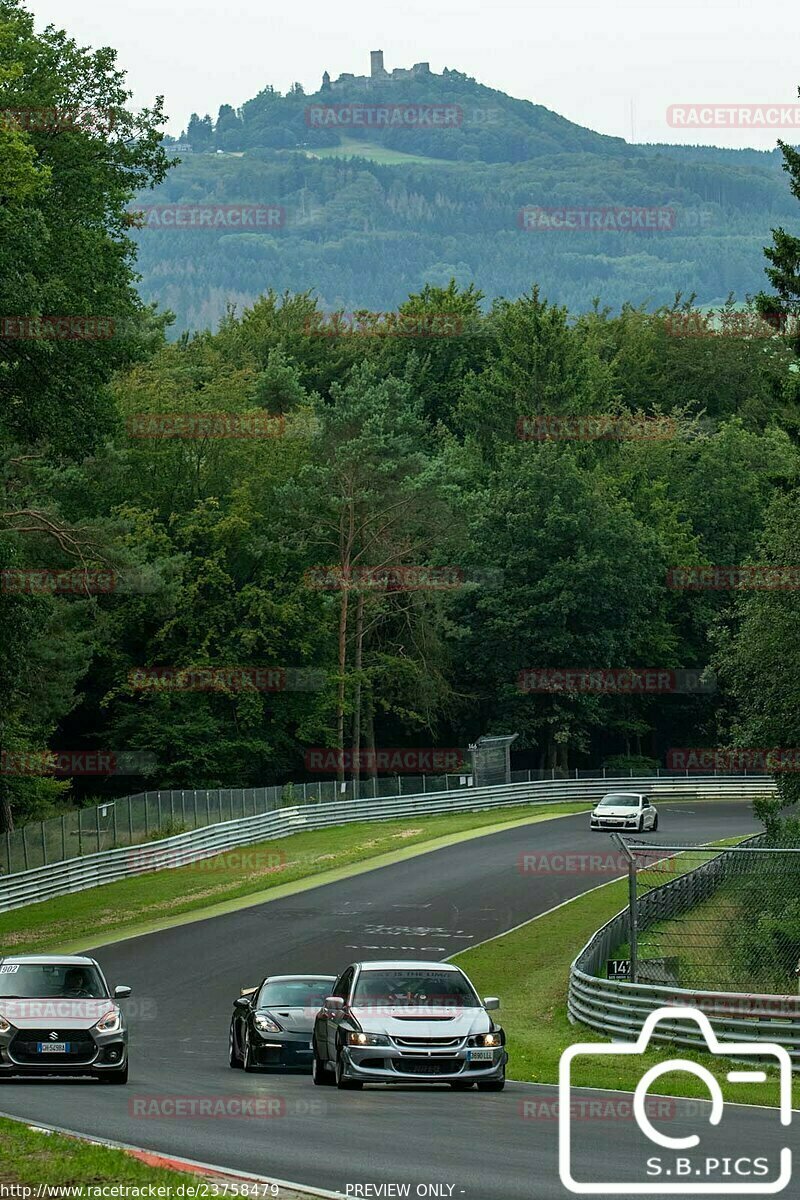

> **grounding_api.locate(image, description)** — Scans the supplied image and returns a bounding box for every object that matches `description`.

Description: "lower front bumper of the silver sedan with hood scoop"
[341,1046,509,1084]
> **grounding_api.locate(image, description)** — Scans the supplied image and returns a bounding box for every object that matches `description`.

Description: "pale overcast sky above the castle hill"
[26,0,800,149]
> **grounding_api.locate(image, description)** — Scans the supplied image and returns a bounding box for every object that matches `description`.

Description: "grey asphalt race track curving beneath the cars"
[0,800,786,1200]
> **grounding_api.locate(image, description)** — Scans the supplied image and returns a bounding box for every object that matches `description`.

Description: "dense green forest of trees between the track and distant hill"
[0,0,800,829]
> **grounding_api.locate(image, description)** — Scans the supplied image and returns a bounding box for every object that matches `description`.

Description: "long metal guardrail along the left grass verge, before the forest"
[0,776,774,912]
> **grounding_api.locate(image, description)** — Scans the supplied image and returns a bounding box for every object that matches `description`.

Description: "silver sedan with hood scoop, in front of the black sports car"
[313,961,509,1092]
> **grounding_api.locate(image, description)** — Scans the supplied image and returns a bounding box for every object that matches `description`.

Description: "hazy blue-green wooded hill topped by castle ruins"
[138,50,796,331]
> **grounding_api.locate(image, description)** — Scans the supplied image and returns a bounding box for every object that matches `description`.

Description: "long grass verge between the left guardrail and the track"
[0,803,591,954]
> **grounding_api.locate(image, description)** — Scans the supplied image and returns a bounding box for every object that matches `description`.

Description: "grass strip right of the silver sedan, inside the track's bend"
[453,880,800,1106]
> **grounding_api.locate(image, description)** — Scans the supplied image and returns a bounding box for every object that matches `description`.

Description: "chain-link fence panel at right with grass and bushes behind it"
[618,836,800,995]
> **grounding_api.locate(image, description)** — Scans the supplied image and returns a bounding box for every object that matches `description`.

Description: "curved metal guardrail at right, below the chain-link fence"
[567,839,800,1070]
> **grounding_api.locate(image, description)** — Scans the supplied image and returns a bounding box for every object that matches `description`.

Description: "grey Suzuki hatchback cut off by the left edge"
[0,955,131,1084]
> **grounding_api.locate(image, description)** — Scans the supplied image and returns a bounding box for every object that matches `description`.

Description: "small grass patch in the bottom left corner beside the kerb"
[0,1120,184,1187]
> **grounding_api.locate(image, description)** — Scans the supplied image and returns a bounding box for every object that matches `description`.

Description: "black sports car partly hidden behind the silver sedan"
[229,976,336,1072]
